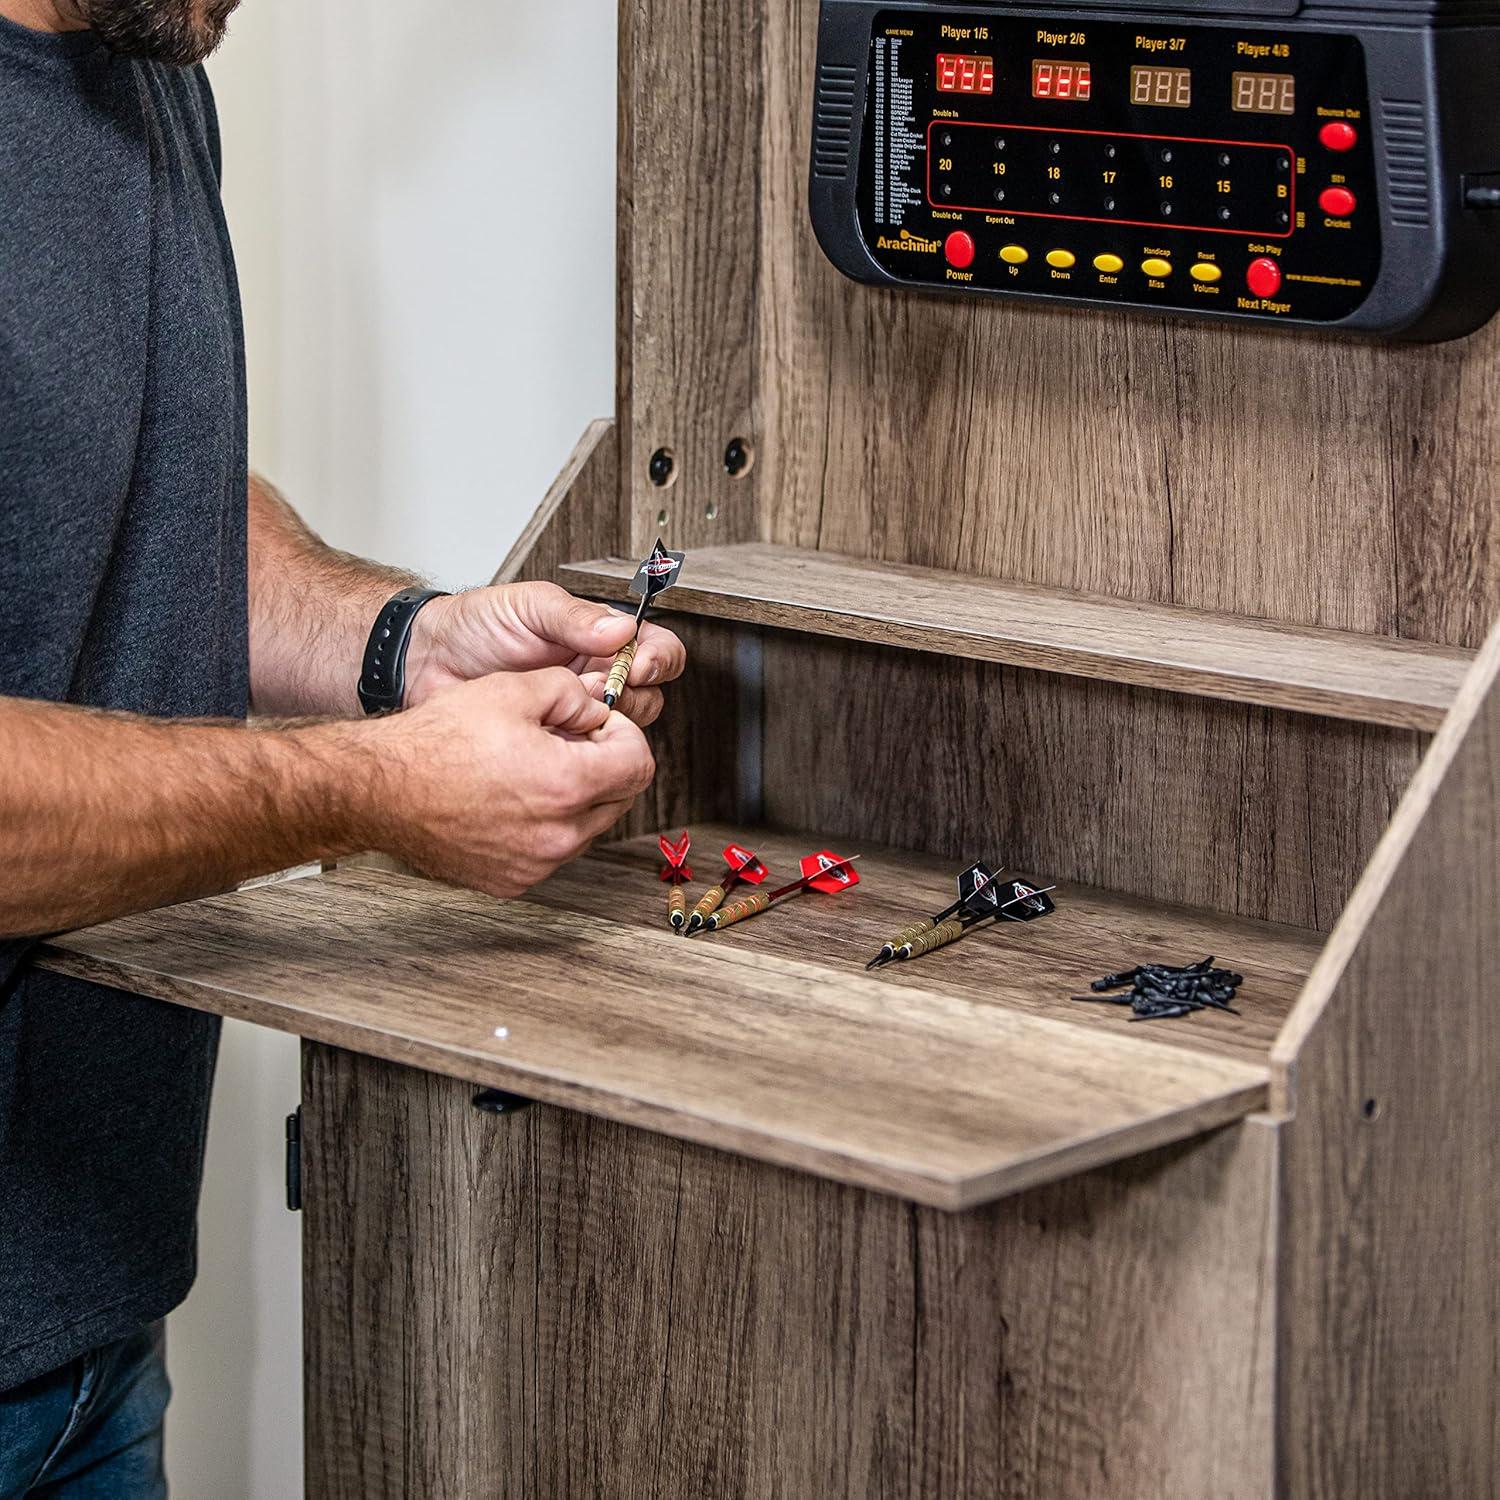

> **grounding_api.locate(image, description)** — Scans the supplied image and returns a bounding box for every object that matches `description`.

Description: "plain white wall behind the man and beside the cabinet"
[168,0,615,1500]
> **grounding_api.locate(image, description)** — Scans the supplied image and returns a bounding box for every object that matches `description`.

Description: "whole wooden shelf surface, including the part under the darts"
[39,827,1320,1208]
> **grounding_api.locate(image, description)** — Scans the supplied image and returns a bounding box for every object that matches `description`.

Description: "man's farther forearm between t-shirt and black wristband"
[249,477,417,717]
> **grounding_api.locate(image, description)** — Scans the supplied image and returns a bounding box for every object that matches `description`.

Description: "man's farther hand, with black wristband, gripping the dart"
[407,584,687,725]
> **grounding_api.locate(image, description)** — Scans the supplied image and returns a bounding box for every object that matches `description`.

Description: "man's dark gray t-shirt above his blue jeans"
[0,20,248,1391]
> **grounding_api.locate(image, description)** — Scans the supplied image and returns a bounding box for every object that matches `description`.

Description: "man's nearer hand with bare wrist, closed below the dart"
[372,666,656,896]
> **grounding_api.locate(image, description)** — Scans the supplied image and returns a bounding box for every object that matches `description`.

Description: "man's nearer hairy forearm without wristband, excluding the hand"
[0,699,380,936]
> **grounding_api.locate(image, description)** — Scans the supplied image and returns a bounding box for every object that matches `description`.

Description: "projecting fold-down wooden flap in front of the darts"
[42,870,1290,1208]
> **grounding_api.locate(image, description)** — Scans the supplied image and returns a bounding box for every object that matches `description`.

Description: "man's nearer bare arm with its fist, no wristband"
[0,668,656,936]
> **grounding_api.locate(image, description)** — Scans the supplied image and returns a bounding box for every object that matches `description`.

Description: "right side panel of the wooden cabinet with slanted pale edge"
[1275,615,1500,1500]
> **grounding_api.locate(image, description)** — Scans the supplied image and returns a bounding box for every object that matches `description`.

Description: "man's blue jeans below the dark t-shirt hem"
[0,1323,171,1500]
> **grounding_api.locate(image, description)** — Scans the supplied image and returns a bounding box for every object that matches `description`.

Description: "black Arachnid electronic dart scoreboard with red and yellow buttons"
[812,0,1500,339]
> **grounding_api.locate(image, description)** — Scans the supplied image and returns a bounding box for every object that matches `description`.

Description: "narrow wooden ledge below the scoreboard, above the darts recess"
[558,543,1473,731]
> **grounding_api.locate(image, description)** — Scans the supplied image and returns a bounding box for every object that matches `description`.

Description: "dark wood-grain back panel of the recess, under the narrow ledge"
[765,635,1422,930]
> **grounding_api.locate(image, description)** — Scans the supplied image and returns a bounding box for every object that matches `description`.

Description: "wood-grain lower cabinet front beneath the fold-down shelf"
[303,1047,1277,1500]
